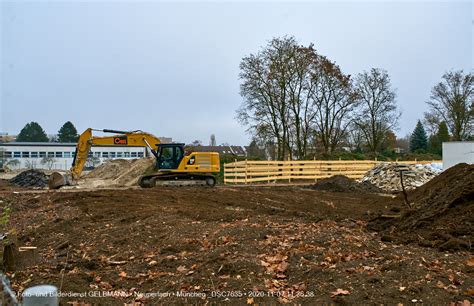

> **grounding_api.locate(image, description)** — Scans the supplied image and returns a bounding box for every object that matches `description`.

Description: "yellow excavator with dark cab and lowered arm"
[49,128,220,189]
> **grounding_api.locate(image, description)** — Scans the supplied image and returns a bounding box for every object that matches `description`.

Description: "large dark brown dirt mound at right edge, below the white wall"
[369,164,474,250]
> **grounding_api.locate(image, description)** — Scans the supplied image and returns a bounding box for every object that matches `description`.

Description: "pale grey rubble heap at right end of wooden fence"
[360,163,438,192]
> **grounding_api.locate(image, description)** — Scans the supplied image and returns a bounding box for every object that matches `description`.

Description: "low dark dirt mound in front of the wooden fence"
[310,175,383,193]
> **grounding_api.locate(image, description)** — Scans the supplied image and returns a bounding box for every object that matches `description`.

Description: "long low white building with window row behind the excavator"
[0,142,149,170]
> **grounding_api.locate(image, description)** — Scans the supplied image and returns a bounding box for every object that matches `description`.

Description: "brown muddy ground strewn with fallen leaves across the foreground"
[0,182,474,305]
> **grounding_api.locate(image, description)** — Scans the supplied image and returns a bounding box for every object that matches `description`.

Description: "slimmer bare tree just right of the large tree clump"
[355,68,400,155]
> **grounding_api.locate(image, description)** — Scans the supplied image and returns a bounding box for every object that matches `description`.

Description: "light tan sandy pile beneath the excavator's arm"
[84,158,155,186]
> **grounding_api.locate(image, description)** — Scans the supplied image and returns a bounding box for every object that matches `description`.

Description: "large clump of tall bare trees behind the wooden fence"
[237,37,357,160]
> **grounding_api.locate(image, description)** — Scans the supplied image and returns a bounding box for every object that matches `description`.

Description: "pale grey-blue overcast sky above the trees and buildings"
[0,0,474,145]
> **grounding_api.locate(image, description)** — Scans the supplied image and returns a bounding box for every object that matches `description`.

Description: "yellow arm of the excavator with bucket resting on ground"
[49,128,161,189]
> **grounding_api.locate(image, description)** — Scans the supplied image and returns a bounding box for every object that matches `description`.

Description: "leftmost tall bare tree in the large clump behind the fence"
[237,37,298,159]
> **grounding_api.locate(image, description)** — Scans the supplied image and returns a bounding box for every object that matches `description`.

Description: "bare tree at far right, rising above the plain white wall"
[425,70,474,141]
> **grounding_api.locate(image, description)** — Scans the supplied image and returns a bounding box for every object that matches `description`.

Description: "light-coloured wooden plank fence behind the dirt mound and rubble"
[224,160,441,184]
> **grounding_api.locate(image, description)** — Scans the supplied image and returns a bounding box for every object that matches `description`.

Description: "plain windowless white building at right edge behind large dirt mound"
[443,141,474,170]
